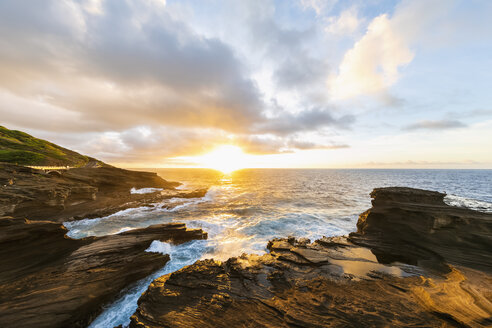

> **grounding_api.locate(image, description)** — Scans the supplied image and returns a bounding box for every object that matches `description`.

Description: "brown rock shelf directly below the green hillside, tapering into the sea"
[0,163,206,222]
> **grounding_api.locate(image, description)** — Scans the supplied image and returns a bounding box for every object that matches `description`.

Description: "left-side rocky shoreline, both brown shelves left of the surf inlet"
[0,163,207,327]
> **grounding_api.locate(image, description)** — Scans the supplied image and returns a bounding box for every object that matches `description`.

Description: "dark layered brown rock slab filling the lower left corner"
[0,217,207,327]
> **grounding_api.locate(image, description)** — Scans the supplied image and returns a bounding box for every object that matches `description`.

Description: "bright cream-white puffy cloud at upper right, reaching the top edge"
[328,0,451,99]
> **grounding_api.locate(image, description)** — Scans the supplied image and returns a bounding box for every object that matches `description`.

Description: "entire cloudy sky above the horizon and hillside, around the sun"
[0,0,492,168]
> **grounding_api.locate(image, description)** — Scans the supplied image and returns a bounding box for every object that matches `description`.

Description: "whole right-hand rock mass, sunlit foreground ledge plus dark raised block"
[130,188,492,328]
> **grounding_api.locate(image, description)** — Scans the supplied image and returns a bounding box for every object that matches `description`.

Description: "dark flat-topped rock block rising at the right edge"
[350,187,492,273]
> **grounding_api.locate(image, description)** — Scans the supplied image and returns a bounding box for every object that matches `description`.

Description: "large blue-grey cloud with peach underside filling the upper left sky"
[0,0,264,131]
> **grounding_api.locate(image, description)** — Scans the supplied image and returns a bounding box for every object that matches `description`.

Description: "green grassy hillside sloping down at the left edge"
[0,126,104,167]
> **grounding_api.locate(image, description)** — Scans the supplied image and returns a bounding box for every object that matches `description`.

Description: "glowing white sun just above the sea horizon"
[198,145,247,173]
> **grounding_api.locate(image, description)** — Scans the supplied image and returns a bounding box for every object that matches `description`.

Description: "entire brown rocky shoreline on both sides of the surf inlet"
[0,163,492,328]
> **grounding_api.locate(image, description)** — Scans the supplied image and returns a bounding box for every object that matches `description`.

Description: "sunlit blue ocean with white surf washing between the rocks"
[65,169,492,328]
